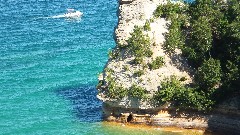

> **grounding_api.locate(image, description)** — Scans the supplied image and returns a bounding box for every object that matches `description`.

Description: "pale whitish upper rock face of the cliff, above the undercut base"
[98,0,192,109]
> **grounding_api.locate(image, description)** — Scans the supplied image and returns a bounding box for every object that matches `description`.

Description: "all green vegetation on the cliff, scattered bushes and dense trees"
[98,0,240,111]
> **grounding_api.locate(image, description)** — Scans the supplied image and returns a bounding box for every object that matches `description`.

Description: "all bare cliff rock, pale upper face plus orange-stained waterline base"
[98,0,240,135]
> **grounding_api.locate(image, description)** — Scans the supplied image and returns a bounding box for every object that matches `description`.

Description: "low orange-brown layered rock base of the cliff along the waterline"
[103,104,240,135]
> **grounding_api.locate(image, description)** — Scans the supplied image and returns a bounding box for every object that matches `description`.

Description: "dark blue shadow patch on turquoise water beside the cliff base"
[55,85,102,122]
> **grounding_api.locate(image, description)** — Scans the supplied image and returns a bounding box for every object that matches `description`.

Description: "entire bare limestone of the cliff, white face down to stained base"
[97,0,240,133]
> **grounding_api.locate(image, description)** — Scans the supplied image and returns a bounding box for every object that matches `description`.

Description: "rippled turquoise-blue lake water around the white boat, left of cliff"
[0,0,197,135]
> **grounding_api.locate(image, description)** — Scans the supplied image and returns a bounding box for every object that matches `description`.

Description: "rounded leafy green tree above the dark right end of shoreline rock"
[196,58,222,90]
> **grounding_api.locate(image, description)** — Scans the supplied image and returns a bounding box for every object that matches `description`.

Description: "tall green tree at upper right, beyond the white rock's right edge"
[183,17,213,67]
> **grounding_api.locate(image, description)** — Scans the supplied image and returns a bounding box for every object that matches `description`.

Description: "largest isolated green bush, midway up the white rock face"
[127,26,153,64]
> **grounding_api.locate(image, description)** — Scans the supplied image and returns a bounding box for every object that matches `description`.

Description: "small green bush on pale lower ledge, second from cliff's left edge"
[129,84,147,99]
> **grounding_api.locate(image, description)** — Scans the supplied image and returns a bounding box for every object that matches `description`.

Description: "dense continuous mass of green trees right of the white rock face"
[154,0,240,110]
